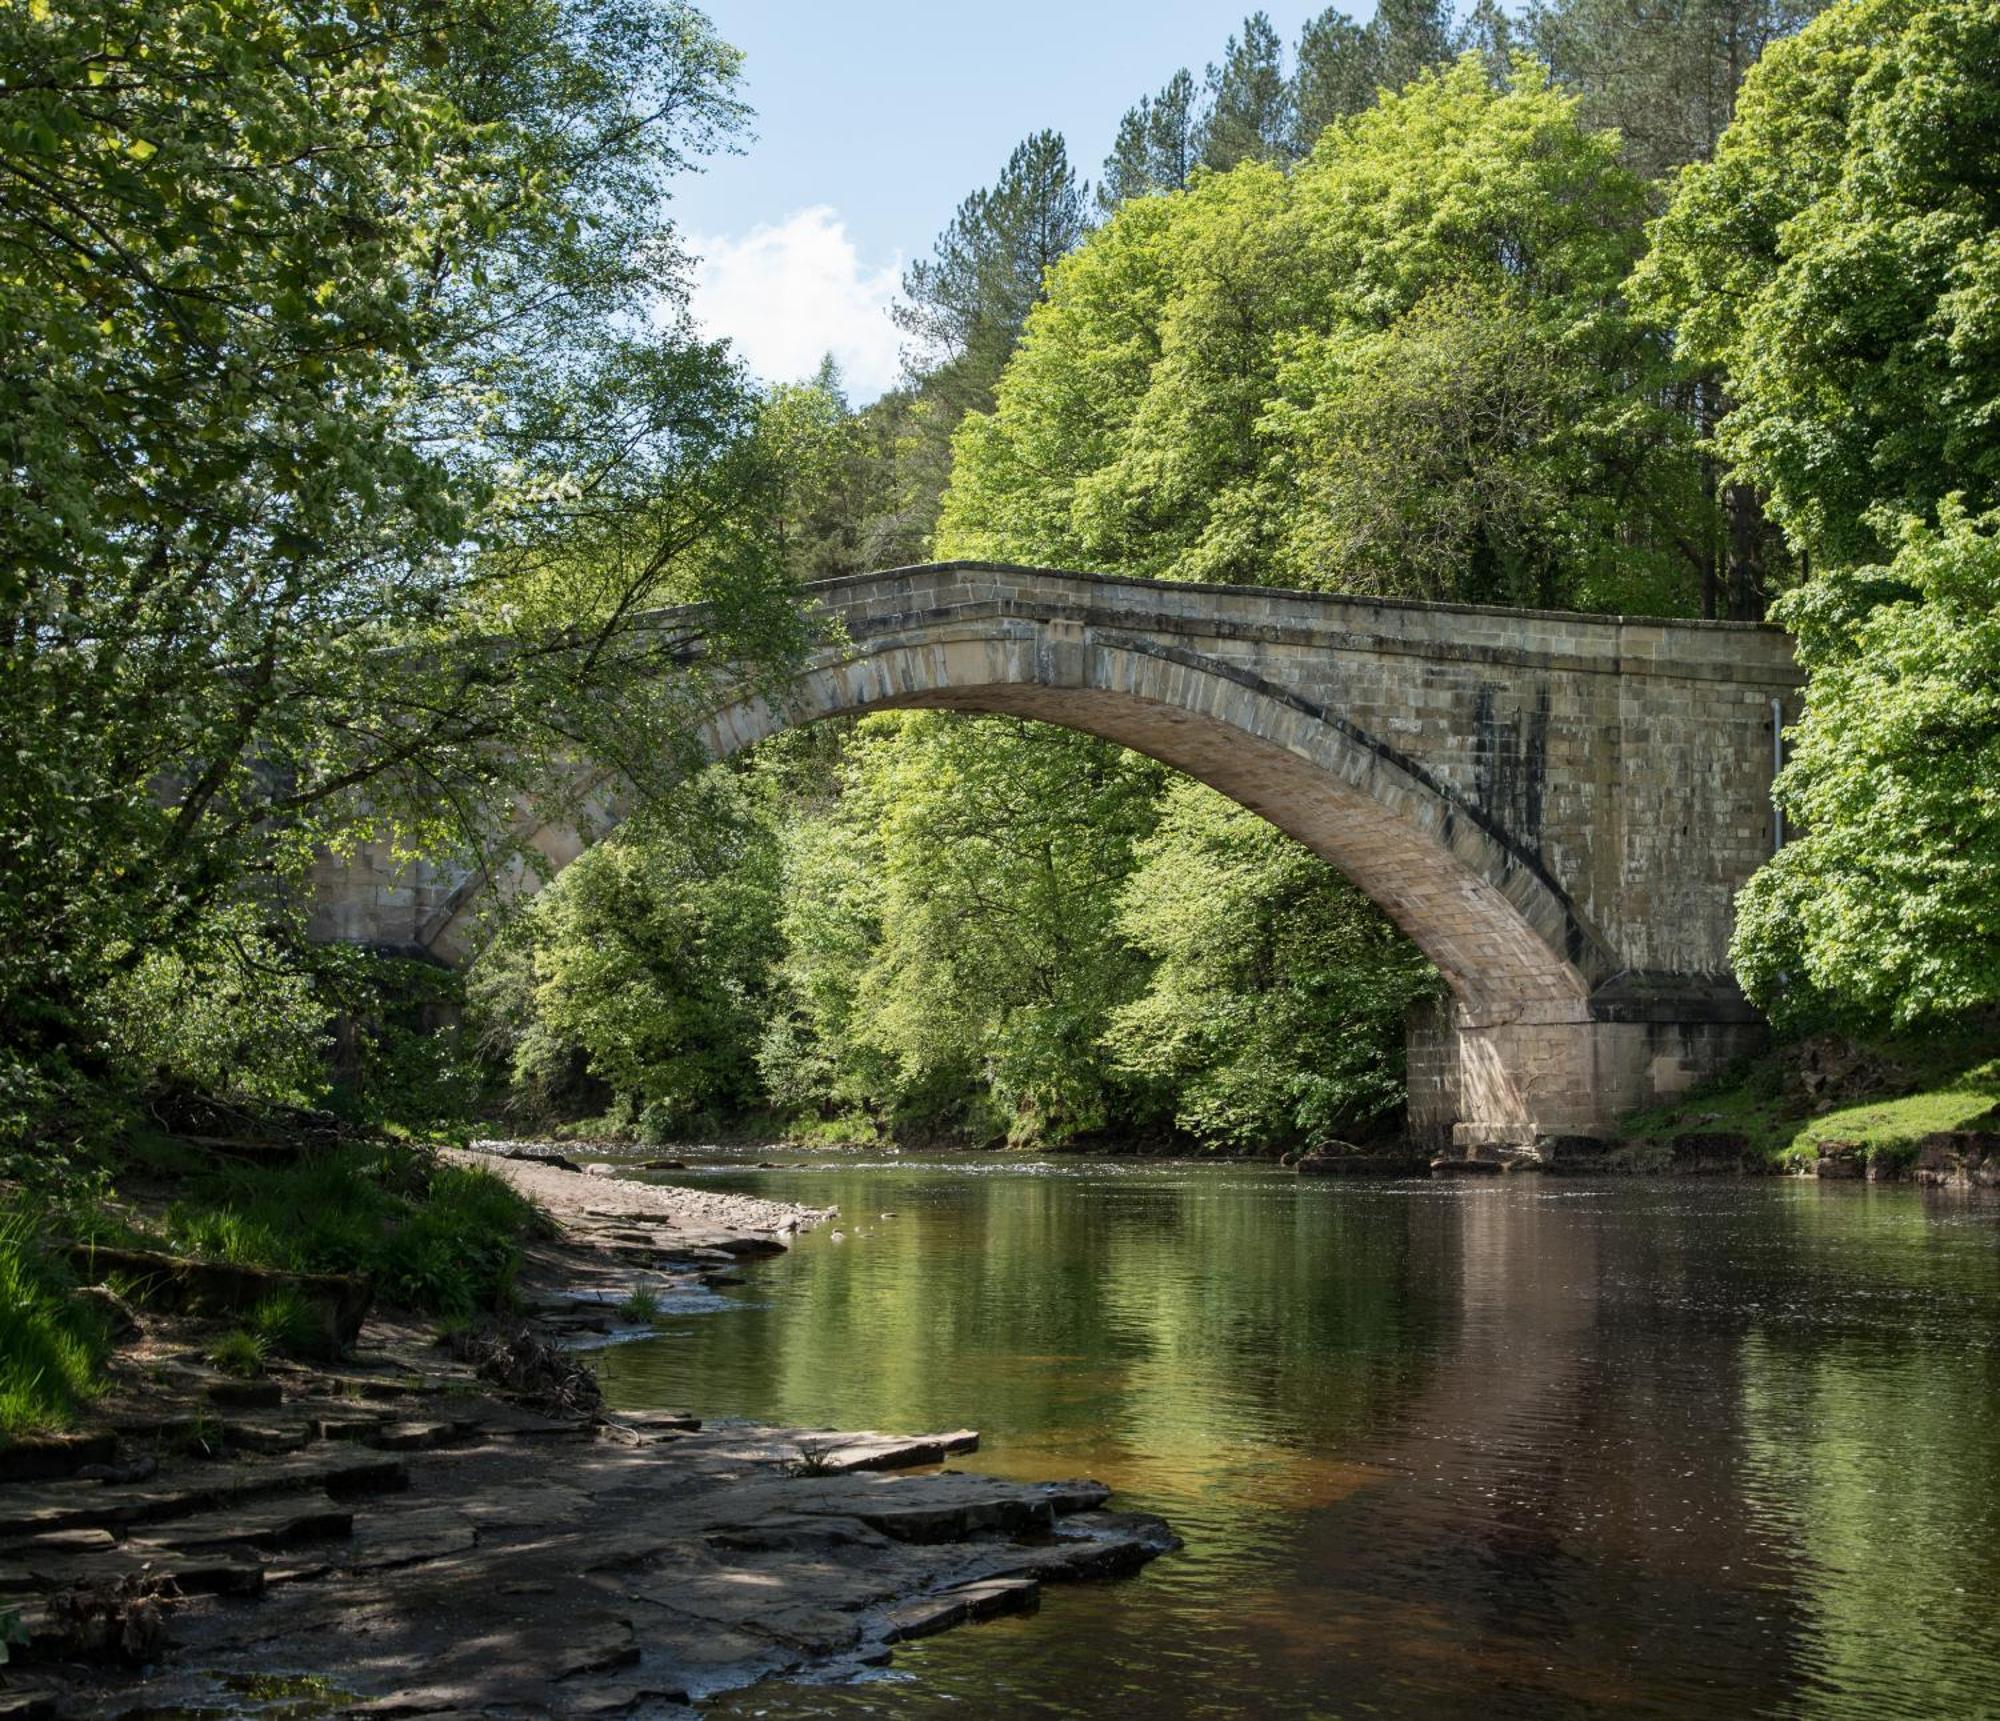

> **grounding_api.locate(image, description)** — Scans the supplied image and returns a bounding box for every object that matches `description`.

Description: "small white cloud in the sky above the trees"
[690,204,900,404]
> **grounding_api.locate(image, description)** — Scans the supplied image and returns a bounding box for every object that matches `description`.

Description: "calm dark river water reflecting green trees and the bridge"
[602,1159,2000,1721]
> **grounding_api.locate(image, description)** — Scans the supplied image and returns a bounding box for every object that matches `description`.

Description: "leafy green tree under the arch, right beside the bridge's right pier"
[1106,778,1438,1149]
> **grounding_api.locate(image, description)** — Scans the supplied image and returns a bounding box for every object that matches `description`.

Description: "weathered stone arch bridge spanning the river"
[314,562,1800,1149]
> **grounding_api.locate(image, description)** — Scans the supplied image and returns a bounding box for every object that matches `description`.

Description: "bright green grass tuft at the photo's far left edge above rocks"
[0,1199,106,1439]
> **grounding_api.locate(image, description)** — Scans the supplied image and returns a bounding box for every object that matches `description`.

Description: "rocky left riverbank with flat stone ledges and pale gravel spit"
[0,1155,1172,1717]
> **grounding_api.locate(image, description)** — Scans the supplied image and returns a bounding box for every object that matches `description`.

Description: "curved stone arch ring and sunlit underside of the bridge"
[684,620,1612,1021]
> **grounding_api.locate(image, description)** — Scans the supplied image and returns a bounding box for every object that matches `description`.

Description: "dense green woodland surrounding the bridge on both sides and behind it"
[0,0,2000,1151]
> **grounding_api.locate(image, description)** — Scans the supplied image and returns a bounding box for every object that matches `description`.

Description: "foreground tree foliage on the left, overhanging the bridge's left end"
[0,0,796,1119]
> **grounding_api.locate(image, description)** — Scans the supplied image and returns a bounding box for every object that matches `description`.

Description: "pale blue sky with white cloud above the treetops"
[676,0,1374,402]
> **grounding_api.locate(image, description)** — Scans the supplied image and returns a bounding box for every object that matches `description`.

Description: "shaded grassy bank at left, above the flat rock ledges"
[0,1137,546,1439]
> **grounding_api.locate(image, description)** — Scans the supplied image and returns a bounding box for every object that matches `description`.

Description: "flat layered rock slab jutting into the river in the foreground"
[27,1413,1172,1715]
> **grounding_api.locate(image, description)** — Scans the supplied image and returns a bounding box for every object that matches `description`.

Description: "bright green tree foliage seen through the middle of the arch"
[764,712,1160,1141]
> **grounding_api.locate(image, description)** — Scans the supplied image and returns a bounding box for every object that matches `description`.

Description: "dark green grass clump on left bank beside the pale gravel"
[164,1143,540,1317]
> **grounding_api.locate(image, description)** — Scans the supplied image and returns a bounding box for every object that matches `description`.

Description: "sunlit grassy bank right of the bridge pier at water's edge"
[1622,1023,2000,1169]
